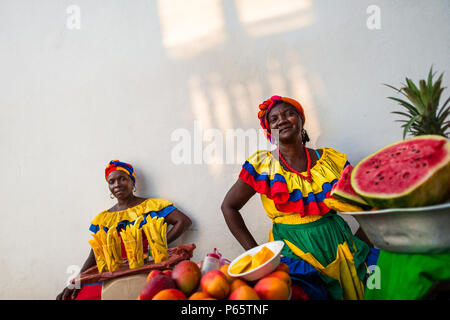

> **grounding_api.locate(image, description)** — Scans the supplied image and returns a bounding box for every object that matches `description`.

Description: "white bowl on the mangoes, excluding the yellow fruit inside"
[228,241,284,281]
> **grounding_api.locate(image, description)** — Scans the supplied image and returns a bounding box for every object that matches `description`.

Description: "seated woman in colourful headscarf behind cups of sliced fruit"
[57,160,191,300]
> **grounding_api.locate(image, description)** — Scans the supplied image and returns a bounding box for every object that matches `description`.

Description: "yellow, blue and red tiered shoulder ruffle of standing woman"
[239,148,348,216]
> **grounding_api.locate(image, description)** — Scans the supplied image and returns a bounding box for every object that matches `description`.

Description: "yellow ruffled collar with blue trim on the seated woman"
[89,198,176,233]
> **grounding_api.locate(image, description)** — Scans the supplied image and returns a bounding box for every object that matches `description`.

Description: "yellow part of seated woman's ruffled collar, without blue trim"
[91,198,173,229]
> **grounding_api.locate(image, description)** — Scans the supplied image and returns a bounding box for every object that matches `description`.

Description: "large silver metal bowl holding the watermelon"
[339,202,450,254]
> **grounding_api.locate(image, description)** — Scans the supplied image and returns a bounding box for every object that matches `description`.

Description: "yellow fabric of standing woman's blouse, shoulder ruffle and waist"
[247,148,347,223]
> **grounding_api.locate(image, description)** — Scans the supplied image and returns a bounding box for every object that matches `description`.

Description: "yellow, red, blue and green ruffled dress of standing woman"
[239,148,370,299]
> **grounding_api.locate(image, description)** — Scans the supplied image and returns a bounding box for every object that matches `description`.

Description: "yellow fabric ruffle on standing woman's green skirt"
[283,239,364,300]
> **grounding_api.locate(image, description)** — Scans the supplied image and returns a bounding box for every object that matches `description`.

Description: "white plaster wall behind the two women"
[0,0,450,299]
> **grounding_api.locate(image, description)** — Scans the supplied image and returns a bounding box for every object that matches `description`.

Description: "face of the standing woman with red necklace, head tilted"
[267,102,303,143]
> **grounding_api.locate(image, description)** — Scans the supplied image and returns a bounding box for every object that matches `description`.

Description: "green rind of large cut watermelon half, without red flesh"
[351,135,450,209]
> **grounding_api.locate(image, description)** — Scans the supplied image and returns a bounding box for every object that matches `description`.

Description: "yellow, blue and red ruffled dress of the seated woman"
[76,198,176,300]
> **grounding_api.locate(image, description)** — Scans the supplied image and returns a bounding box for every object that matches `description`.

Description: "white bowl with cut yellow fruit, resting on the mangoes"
[228,241,284,281]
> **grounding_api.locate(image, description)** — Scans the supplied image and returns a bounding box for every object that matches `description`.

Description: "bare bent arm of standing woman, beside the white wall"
[221,179,258,250]
